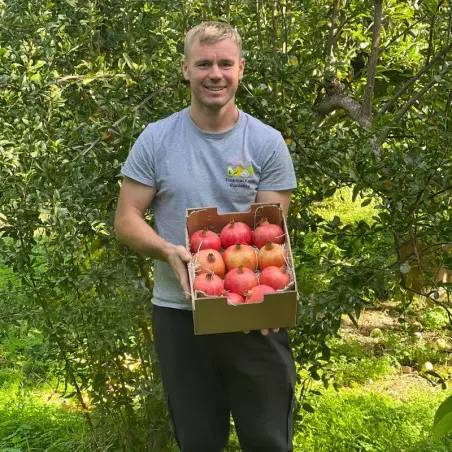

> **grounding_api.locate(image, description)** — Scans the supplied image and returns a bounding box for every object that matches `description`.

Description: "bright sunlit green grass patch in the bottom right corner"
[294,388,452,452]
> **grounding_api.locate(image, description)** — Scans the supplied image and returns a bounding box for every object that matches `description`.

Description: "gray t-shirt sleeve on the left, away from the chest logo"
[121,130,156,187]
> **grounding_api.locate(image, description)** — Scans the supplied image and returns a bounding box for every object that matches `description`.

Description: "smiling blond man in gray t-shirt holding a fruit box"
[115,22,296,452]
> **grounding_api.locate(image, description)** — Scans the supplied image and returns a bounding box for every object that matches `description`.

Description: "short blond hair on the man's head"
[184,21,242,59]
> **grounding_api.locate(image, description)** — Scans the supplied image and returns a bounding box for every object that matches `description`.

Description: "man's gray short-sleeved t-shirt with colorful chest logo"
[122,108,297,309]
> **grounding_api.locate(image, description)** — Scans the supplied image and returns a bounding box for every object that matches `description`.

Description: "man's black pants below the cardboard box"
[152,306,295,452]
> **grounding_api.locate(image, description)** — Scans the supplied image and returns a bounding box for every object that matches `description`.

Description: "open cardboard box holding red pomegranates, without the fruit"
[186,203,299,335]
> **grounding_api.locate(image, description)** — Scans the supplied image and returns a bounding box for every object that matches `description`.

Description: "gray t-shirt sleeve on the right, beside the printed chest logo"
[258,134,297,191]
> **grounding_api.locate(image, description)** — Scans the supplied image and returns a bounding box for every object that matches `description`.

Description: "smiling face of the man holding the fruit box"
[182,39,245,111]
